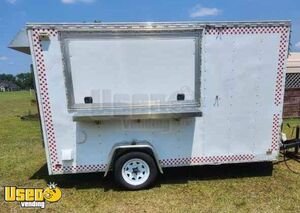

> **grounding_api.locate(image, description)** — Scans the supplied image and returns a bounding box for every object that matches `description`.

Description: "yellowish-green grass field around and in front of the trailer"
[0,92,300,212]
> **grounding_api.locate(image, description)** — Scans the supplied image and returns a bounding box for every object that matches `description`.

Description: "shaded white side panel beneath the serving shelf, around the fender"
[76,118,200,165]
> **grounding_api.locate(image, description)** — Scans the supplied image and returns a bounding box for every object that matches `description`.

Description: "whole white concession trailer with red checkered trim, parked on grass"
[10,21,290,189]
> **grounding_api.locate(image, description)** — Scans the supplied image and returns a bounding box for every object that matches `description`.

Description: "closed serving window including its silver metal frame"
[60,31,201,120]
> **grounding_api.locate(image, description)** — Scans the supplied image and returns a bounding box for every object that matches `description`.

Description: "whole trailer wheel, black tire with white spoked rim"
[114,152,157,190]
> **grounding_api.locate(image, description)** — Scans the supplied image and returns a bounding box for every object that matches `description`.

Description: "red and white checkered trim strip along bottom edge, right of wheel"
[160,154,254,166]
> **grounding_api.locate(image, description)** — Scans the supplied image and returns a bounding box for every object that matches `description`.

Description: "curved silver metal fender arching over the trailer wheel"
[104,140,163,177]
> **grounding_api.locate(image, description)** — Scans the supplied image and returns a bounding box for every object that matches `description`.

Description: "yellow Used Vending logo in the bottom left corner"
[4,183,62,209]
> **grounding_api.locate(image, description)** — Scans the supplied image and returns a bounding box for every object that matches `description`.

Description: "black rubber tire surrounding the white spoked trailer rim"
[114,152,157,190]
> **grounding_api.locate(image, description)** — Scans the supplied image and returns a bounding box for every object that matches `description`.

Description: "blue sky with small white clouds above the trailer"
[0,0,300,74]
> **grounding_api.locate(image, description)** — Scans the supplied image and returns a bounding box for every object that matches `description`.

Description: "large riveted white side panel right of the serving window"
[202,34,280,155]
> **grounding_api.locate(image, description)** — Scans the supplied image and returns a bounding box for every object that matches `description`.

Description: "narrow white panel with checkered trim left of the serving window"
[29,29,76,174]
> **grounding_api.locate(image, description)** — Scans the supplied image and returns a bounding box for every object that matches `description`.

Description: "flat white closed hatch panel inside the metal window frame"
[68,37,195,104]
